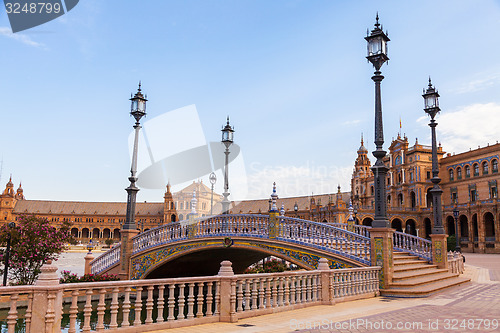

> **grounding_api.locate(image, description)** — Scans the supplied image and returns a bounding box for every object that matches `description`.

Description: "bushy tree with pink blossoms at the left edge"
[0,215,71,284]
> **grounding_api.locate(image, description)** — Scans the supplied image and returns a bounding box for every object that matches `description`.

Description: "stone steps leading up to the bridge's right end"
[380,252,470,297]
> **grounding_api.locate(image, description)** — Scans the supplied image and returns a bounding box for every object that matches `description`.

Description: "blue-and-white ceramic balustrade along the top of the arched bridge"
[128,214,370,264]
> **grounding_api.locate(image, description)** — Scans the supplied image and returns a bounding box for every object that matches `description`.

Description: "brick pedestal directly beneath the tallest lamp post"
[370,228,394,289]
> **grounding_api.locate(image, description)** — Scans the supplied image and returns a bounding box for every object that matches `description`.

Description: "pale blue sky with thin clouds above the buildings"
[0,0,500,202]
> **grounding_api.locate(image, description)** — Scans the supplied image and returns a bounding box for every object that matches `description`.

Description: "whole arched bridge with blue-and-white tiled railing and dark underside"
[91,214,378,279]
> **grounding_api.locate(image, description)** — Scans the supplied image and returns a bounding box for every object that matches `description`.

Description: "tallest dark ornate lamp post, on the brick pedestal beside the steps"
[365,13,390,228]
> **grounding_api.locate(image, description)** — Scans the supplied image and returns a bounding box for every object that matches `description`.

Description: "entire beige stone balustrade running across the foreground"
[0,258,380,333]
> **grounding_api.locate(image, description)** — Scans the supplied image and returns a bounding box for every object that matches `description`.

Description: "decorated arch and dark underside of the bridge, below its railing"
[131,237,365,279]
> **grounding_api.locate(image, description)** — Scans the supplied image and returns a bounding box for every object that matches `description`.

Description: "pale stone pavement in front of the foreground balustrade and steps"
[152,253,500,333]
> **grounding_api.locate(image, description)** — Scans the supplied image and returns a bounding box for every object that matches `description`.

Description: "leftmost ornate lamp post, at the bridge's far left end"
[122,82,147,230]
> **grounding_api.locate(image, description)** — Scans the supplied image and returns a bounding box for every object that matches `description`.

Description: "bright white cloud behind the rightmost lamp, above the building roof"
[418,103,500,153]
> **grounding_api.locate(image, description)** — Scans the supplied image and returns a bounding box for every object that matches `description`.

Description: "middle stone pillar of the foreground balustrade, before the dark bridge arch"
[218,260,238,323]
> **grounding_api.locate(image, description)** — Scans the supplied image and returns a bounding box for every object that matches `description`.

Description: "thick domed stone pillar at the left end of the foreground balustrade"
[30,260,62,333]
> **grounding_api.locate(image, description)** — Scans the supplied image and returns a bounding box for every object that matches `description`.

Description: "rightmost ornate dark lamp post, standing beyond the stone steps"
[422,77,445,234]
